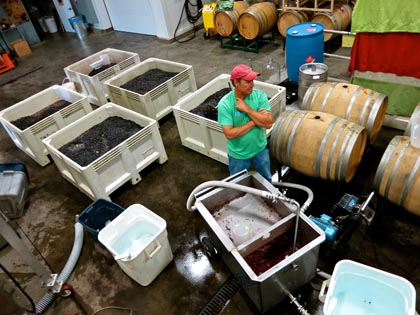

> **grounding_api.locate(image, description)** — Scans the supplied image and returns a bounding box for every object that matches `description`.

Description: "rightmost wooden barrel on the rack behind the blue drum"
[312,4,352,42]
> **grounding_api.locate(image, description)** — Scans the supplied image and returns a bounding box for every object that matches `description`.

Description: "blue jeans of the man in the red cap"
[228,148,271,183]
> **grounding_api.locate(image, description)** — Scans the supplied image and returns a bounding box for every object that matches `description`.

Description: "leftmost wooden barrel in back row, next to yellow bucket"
[214,1,249,37]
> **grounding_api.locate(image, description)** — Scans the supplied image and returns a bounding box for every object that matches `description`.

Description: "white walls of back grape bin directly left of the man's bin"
[105,58,197,120]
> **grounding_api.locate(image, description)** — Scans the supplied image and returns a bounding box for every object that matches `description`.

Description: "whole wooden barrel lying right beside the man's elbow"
[270,110,367,182]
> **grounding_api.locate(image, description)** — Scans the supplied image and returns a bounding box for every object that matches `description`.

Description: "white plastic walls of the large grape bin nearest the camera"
[43,103,168,201]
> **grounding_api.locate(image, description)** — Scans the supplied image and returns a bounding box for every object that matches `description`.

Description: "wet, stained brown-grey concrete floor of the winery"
[0,30,420,315]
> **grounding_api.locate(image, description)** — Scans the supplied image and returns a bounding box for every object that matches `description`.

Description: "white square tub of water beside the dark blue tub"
[98,204,173,286]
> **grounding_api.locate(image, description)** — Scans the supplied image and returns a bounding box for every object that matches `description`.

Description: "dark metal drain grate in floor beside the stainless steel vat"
[199,276,241,315]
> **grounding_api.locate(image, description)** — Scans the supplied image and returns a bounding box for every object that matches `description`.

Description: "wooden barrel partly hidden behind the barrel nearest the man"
[300,82,388,144]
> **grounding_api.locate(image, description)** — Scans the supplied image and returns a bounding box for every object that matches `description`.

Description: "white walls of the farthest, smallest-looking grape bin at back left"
[64,48,140,106]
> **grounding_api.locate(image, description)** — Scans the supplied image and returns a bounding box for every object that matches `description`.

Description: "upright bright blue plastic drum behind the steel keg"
[286,22,324,82]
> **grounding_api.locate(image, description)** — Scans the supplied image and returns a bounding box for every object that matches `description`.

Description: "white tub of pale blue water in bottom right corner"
[324,260,416,315]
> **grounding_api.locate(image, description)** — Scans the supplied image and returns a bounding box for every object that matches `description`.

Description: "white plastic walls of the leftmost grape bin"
[0,85,92,166]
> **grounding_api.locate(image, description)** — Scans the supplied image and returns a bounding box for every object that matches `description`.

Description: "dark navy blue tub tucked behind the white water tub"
[77,199,125,240]
